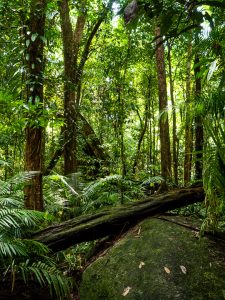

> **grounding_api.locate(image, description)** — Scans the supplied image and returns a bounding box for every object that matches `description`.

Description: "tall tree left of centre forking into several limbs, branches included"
[59,0,112,174]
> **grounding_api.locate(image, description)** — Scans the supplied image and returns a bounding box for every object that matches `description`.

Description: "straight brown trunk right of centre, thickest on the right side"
[155,27,171,185]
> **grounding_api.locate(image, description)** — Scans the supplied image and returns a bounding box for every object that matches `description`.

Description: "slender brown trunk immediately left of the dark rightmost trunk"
[184,43,193,185]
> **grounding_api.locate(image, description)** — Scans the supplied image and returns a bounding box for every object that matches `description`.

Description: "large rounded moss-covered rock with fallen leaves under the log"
[80,218,225,300]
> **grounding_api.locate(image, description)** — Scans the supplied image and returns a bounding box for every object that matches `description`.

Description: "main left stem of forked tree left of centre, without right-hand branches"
[59,0,83,175]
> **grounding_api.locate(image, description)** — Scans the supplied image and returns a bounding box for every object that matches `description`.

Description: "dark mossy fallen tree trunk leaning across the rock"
[33,187,204,252]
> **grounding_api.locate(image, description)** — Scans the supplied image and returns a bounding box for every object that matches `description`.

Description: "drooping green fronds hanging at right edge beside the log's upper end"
[202,93,225,230]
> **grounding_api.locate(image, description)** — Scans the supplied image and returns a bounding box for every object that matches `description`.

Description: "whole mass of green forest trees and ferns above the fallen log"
[0,0,225,298]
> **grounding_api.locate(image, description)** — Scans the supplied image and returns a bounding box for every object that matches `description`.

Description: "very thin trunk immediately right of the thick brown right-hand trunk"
[168,45,178,184]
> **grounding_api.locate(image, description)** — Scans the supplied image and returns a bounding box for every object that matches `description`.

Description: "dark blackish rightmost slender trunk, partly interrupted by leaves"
[194,55,204,180]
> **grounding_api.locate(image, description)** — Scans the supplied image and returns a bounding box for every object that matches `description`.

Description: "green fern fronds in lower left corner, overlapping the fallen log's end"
[0,174,70,299]
